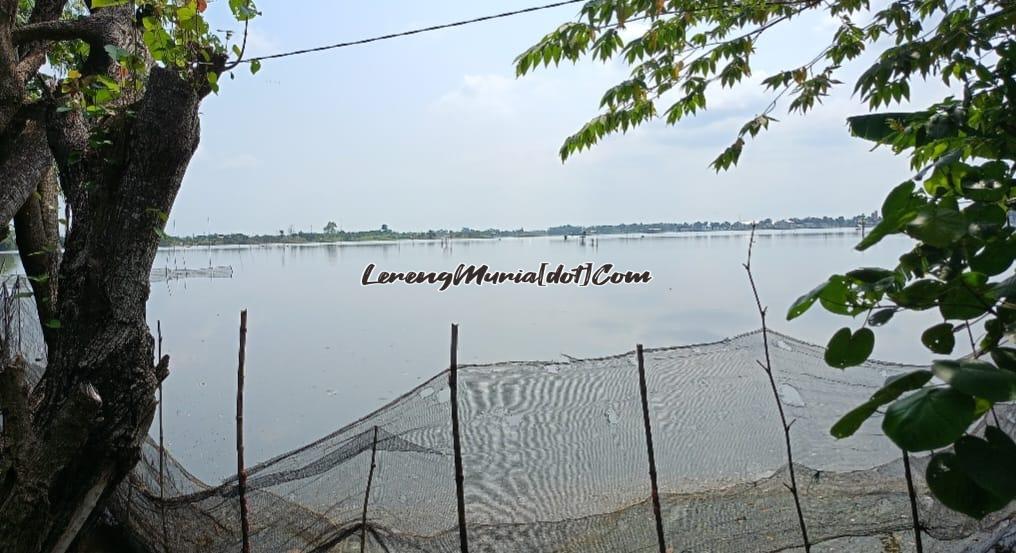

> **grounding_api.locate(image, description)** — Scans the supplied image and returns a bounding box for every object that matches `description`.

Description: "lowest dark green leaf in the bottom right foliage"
[925,452,1009,519]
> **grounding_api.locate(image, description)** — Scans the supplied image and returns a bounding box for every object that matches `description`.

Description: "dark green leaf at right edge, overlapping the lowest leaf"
[953,426,1016,501]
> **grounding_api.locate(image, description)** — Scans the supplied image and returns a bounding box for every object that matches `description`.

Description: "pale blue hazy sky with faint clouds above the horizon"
[168,0,941,235]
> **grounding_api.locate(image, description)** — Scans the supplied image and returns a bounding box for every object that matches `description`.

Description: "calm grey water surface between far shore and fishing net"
[7,231,932,480]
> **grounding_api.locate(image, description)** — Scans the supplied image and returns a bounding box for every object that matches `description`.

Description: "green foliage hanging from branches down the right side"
[516,0,1016,517]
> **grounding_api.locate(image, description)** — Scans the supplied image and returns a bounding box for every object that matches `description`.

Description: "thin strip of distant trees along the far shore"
[152,213,879,246]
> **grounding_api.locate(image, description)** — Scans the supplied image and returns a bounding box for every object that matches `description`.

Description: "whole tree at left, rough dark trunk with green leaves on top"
[0,0,257,553]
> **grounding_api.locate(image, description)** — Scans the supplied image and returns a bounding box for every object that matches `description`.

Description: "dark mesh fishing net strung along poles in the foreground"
[1,286,1016,553]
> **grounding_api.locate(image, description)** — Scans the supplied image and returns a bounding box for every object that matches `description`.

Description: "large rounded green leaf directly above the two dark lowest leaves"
[882,388,976,451]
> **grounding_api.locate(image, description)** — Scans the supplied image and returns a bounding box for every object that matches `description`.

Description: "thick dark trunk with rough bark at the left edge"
[0,63,206,553]
